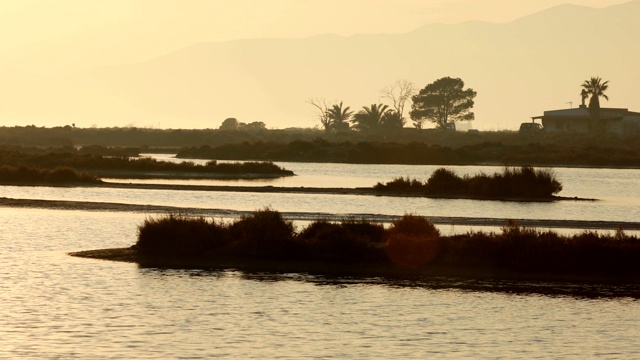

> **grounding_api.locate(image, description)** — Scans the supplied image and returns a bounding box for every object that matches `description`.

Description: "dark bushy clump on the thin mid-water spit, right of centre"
[374,166,562,198]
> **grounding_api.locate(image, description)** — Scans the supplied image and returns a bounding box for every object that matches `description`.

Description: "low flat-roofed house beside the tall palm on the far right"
[531,96,640,135]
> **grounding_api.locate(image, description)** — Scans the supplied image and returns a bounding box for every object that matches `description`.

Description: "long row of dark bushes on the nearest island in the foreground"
[134,208,640,275]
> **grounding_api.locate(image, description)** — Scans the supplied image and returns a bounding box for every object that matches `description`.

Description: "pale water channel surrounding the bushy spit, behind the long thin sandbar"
[5,161,640,226]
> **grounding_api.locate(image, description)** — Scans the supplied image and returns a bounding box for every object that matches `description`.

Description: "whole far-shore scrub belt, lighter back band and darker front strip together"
[0,126,640,167]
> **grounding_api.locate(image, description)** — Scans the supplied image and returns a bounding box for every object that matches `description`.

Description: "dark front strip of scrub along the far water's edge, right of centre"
[177,139,640,167]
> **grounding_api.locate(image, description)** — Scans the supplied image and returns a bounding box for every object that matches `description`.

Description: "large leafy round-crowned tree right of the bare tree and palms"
[410,77,477,128]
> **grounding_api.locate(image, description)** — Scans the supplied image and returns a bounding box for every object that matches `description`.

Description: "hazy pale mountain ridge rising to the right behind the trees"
[0,0,640,129]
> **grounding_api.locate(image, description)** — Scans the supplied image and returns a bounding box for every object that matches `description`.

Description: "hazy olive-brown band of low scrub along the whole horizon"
[0,126,640,150]
